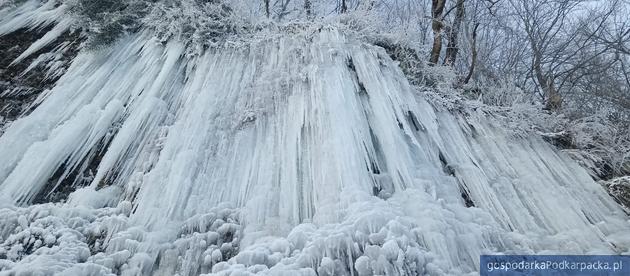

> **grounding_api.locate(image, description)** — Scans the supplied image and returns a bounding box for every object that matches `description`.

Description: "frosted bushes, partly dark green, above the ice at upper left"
[67,0,245,47]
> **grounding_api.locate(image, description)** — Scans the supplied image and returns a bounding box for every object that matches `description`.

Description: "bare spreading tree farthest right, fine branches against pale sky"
[511,0,621,111]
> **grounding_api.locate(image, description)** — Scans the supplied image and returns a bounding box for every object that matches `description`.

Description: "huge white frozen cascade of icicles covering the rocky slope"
[0,1,630,276]
